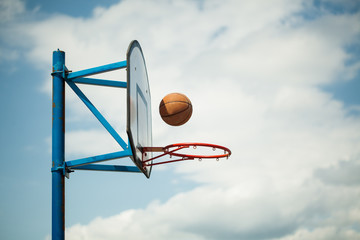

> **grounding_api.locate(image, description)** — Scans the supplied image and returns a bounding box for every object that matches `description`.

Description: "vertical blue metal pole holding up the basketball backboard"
[52,50,65,240]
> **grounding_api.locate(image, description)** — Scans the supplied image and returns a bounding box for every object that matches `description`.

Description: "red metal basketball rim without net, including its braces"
[142,143,231,167]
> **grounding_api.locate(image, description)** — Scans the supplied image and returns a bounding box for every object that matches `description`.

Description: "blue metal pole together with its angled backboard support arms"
[51,50,141,240]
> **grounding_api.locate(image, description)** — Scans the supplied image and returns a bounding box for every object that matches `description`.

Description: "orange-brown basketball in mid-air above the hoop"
[159,93,192,126]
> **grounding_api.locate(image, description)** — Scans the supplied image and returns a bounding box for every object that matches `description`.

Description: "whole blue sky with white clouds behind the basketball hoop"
[0,0,360,240]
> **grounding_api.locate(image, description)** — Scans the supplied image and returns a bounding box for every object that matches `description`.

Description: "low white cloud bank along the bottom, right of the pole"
[66,182,359,239]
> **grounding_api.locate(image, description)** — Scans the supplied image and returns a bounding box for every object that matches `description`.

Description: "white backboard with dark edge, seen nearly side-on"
[126,40,152,178]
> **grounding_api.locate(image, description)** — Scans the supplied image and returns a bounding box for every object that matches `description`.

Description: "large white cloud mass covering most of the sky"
[7,1,360,240]
